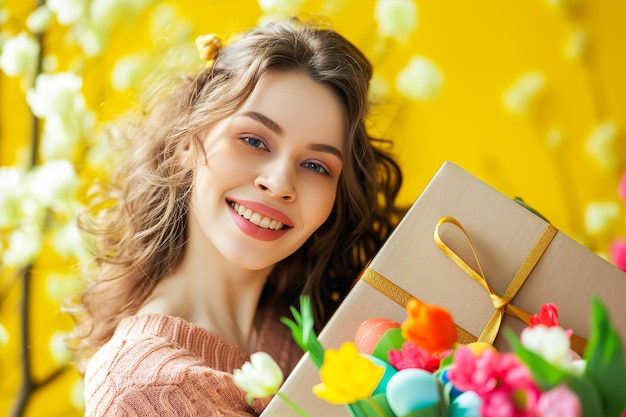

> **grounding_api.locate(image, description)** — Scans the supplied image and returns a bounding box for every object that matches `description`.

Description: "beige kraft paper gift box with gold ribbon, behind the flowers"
[263,162,626,417]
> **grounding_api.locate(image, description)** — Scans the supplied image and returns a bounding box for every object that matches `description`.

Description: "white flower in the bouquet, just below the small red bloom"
[520,324,570,368]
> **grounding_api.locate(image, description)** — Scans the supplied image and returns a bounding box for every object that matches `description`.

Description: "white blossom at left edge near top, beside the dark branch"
[0,32,40,77]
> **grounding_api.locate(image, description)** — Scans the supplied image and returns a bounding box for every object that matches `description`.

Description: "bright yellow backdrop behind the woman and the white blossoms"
[0,0,626,416]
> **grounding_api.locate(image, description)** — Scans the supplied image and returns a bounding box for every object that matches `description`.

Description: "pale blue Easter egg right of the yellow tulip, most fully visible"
[387,368,441,416]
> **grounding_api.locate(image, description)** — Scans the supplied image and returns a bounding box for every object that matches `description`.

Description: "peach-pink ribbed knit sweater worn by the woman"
[85,302,302,417]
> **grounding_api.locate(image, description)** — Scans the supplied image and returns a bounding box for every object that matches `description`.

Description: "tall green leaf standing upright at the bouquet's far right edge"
[585,297,626,417]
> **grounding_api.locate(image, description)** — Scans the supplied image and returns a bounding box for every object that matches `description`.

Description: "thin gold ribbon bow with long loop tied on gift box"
[434,217,558,344]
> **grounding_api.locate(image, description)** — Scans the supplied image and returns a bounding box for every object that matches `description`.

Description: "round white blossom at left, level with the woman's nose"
[29,159,78,210]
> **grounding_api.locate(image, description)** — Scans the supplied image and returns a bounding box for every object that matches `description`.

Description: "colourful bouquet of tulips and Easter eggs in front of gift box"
[234,297,626,417]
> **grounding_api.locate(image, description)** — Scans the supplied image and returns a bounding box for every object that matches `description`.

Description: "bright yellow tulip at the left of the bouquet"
[313,342,385,404]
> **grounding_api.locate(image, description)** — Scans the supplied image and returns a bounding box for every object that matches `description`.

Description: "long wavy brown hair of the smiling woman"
[68,19,404,370]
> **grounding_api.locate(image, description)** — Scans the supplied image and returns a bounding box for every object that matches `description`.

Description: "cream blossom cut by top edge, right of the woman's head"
[374,0,417,41]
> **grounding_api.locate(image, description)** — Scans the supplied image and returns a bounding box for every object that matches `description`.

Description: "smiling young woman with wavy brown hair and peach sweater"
[67,19,402,416]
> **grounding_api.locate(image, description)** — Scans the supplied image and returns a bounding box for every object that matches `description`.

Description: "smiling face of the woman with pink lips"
[187,72,347,270]
